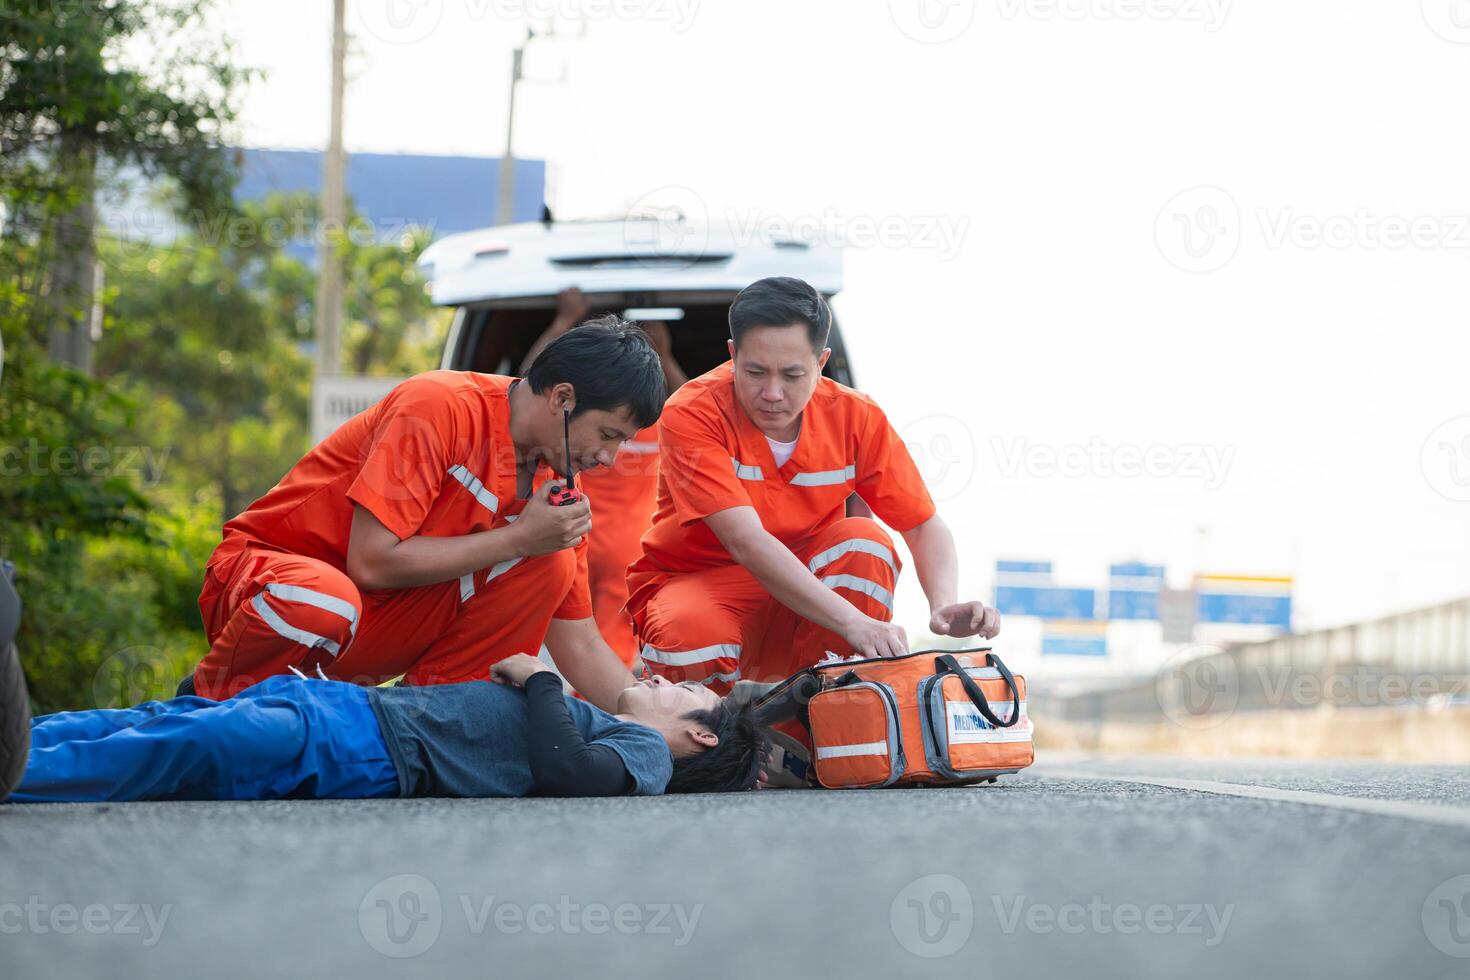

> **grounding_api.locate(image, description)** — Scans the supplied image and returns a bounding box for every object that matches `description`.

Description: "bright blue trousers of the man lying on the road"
[7,674,398,802]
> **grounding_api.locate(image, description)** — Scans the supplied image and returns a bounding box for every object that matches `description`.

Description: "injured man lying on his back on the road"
[10,654,769,802]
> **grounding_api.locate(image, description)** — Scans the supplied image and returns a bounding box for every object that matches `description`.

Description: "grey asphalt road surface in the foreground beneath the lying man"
[0,757,1470,980]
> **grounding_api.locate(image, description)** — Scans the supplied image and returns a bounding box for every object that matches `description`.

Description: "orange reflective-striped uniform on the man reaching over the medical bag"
[628,361,935,693]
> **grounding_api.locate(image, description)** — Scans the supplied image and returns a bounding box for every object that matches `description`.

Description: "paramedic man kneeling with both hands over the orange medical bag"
[628,278,1000,693]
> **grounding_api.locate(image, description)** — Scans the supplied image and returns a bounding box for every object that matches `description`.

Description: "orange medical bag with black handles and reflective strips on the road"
[759,646,1035,789]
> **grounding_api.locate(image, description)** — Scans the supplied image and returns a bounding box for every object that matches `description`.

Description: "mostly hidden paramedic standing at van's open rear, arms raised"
[520,287,689,669]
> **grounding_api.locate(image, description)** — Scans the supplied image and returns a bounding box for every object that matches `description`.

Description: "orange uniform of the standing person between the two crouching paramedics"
[576,425,659,669]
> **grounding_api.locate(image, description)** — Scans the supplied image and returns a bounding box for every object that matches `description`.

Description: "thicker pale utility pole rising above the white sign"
[316,0,347,378]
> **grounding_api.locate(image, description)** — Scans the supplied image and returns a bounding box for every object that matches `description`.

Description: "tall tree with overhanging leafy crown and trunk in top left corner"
[0,0,251,372]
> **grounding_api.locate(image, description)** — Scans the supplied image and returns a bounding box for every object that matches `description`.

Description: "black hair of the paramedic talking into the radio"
[526,313,669,429]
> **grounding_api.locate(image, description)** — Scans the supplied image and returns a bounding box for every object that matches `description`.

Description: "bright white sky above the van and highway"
[221,0,1470,640]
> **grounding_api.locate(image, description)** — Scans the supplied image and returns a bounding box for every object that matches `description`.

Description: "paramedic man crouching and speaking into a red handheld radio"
[185,317,664,710]
